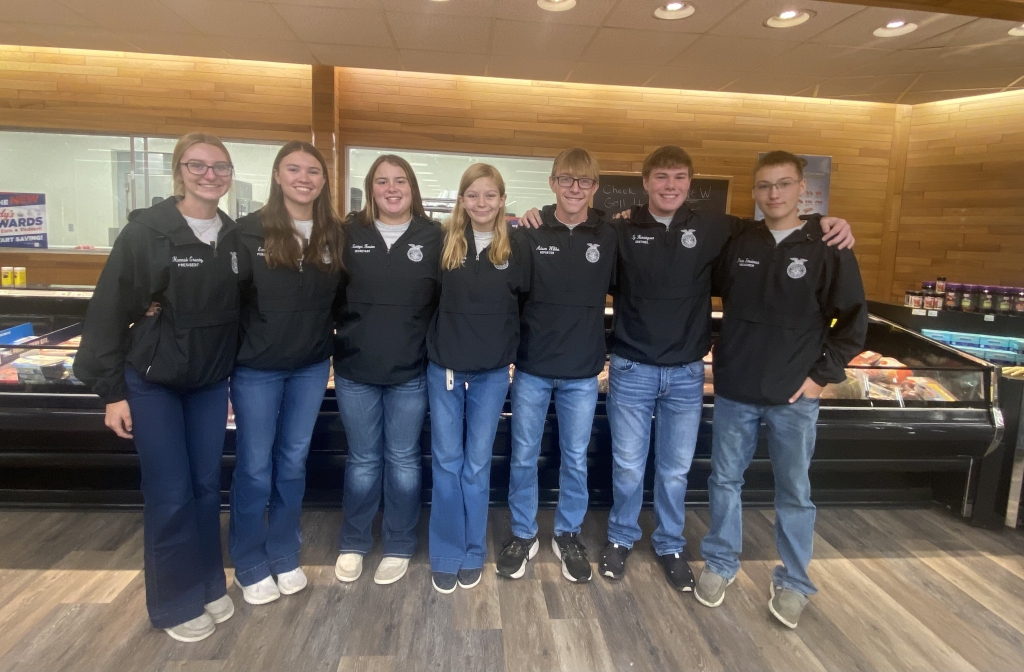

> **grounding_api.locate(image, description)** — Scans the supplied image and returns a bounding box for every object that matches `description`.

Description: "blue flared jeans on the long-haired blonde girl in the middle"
[427,362,509,574]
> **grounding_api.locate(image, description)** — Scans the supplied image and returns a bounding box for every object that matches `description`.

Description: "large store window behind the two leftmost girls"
[0,130,281,250]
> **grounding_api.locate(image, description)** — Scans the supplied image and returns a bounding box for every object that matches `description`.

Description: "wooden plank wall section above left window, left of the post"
[0,46,312,140]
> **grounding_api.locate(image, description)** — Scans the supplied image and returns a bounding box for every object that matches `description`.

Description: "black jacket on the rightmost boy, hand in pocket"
[714,216,867,405]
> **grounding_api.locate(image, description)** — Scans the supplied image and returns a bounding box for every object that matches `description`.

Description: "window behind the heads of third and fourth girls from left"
[345,148,555,219]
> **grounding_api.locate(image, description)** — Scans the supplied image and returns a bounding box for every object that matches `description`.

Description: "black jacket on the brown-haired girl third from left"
[334,216,442,385]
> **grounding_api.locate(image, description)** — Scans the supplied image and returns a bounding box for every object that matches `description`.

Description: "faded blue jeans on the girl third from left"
[334,374,427,557]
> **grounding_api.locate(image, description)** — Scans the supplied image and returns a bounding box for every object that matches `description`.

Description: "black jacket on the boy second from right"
[611,204,744,367]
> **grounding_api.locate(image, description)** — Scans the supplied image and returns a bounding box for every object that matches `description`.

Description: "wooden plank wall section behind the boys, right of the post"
[336,68,897,293]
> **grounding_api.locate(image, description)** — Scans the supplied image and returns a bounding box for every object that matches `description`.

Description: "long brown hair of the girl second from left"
[259,140,344,270]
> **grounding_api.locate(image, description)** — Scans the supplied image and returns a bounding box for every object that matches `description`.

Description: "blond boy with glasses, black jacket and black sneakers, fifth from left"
[497,149,615,582]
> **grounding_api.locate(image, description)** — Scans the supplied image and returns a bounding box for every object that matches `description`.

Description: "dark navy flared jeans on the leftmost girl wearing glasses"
[125,366,227,628]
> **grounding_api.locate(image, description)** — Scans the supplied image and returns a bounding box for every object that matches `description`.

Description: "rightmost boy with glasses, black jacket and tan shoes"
[694,152,867,628]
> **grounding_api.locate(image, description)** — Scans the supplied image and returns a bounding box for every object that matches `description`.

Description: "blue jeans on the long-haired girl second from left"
[227,360,331,586]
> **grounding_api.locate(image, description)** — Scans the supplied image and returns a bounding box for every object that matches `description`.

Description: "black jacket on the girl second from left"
[237,212,341,370]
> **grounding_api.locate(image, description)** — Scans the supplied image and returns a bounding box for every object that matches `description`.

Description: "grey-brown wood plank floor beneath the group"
[0,509,1024,672]
